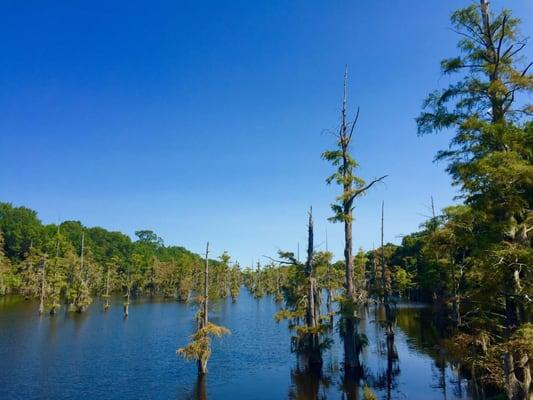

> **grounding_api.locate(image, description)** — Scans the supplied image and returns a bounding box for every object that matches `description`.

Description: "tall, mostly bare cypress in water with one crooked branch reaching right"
[322,71,386,370]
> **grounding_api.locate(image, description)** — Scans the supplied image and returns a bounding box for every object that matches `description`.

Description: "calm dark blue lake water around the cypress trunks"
[0,289,471,400]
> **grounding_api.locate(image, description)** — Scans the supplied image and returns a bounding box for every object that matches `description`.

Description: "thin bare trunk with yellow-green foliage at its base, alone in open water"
[177,242,230,375]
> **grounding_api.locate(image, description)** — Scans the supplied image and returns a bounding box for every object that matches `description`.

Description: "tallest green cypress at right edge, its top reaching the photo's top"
[417,0,533,399]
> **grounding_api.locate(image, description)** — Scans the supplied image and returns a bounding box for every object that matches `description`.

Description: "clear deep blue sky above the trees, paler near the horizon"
[0,0,533,264]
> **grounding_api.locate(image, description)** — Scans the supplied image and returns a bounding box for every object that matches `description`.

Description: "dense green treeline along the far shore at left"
[0,203,241,315]
